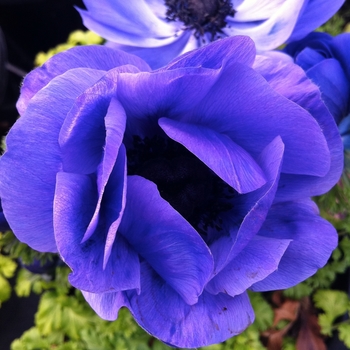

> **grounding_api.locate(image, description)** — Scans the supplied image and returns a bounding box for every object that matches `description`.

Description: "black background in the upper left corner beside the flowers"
[0,0,85,142]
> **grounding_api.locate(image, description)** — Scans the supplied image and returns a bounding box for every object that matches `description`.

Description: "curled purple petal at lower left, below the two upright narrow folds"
[54,168,140,293]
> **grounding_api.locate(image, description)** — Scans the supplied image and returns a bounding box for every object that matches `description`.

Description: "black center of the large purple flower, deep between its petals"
[127,136,235,236]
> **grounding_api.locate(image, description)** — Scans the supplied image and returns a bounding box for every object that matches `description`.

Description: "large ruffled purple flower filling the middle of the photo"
[0,36,343,347]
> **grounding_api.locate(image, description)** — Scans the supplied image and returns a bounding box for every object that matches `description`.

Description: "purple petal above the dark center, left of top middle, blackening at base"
[118,68,219,148]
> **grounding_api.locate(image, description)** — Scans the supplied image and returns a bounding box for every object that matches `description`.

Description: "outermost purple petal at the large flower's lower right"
[252,200,338,291]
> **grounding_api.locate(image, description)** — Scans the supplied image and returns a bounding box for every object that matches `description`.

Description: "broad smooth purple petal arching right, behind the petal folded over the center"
[197,63,330,176]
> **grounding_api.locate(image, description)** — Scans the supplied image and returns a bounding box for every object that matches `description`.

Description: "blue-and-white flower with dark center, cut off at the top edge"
[78,0,344,69]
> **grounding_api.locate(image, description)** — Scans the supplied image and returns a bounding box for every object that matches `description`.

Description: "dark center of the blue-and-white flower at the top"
[165,0,235,41]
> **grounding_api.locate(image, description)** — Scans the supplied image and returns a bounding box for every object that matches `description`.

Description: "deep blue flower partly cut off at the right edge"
[284,33,350,149]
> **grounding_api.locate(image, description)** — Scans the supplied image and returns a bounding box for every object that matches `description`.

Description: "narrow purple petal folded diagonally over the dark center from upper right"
[159,118,266,193]
